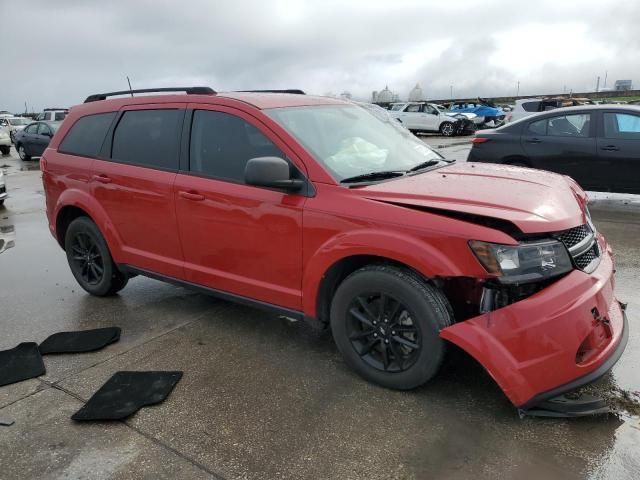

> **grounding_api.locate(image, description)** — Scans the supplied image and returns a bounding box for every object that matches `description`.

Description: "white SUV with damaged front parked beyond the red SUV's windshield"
[389,102,476,137]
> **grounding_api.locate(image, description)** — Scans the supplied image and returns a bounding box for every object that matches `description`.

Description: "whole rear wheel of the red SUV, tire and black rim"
[64,217,128,297]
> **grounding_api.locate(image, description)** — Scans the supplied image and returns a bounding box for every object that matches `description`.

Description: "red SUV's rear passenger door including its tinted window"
[91,103,186,278]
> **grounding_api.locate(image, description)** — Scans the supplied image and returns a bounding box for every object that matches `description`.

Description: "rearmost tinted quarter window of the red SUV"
[58,112,116,157]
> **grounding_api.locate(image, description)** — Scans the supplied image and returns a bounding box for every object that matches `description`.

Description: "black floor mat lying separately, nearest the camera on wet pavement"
[71,372,182,421]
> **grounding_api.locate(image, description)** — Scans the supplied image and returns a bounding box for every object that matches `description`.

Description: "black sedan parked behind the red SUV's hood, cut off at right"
[468,105,640,193]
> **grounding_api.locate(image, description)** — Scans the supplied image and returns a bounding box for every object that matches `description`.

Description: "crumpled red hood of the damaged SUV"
[359,163,587,233]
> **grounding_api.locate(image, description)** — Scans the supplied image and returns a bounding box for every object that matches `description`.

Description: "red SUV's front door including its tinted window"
[175,105,306,310]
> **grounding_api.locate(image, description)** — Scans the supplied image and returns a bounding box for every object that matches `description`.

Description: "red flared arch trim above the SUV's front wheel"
[302,228,463,317]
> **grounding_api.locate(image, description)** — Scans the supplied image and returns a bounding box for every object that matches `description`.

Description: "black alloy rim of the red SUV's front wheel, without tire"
[347,292,422,372]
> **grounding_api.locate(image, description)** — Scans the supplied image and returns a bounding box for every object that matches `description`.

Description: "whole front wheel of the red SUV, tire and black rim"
[331,265,453,390]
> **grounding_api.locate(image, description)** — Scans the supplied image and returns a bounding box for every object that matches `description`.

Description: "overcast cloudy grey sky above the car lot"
[0,0,640,111]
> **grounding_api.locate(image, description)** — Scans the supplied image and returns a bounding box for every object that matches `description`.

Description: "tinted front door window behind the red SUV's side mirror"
[189,110,285,182]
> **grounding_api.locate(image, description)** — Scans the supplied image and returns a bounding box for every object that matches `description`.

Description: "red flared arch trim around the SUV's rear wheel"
[52,188,122,263]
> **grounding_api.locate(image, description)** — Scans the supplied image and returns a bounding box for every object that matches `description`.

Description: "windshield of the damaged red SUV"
[266,105,445,181]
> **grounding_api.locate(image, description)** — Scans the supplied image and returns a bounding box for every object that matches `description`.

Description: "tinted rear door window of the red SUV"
[111,110,184,170]
